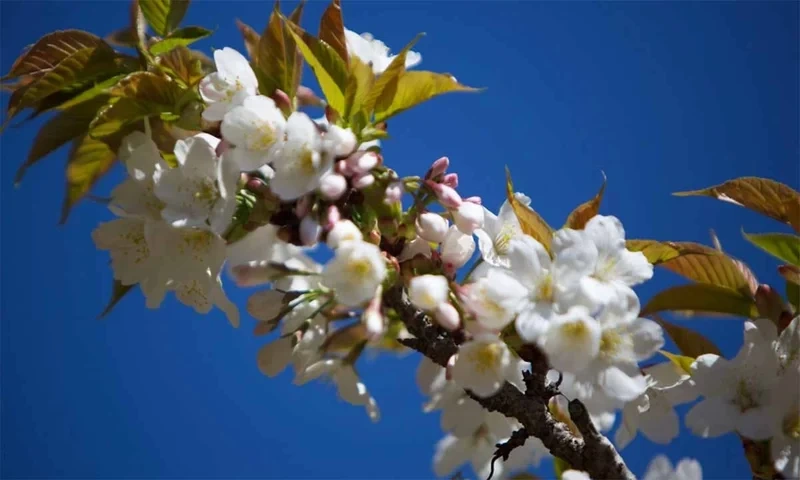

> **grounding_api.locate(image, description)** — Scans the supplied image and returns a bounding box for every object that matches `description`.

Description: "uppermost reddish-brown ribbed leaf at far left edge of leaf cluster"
[2,30,105,81]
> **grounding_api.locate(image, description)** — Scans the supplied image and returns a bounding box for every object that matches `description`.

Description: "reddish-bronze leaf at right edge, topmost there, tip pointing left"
[673,177,800,232]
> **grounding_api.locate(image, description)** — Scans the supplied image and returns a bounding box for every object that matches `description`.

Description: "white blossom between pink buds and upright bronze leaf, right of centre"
[475,193,531,267]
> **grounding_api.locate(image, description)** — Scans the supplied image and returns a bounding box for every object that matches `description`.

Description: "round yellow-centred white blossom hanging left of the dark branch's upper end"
[322,241,386,307]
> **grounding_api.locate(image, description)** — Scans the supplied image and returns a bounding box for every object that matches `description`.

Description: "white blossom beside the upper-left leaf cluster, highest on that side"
[200,47,258,122]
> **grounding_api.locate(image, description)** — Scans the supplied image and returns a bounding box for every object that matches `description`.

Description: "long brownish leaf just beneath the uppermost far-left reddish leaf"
[8,44,118,124]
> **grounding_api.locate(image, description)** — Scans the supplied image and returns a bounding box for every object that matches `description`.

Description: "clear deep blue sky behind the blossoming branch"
[0,1,800,479]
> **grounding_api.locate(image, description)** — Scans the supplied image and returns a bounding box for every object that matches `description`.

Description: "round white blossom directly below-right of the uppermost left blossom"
[221,95,286,172]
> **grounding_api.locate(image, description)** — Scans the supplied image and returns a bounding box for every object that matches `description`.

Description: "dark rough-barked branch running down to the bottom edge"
[383,285,636,480]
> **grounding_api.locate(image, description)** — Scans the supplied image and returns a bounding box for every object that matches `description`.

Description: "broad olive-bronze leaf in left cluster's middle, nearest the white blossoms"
[89,72,182,138]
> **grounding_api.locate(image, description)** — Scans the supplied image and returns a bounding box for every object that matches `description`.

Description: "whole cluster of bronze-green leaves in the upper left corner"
[2,0,216,222]
